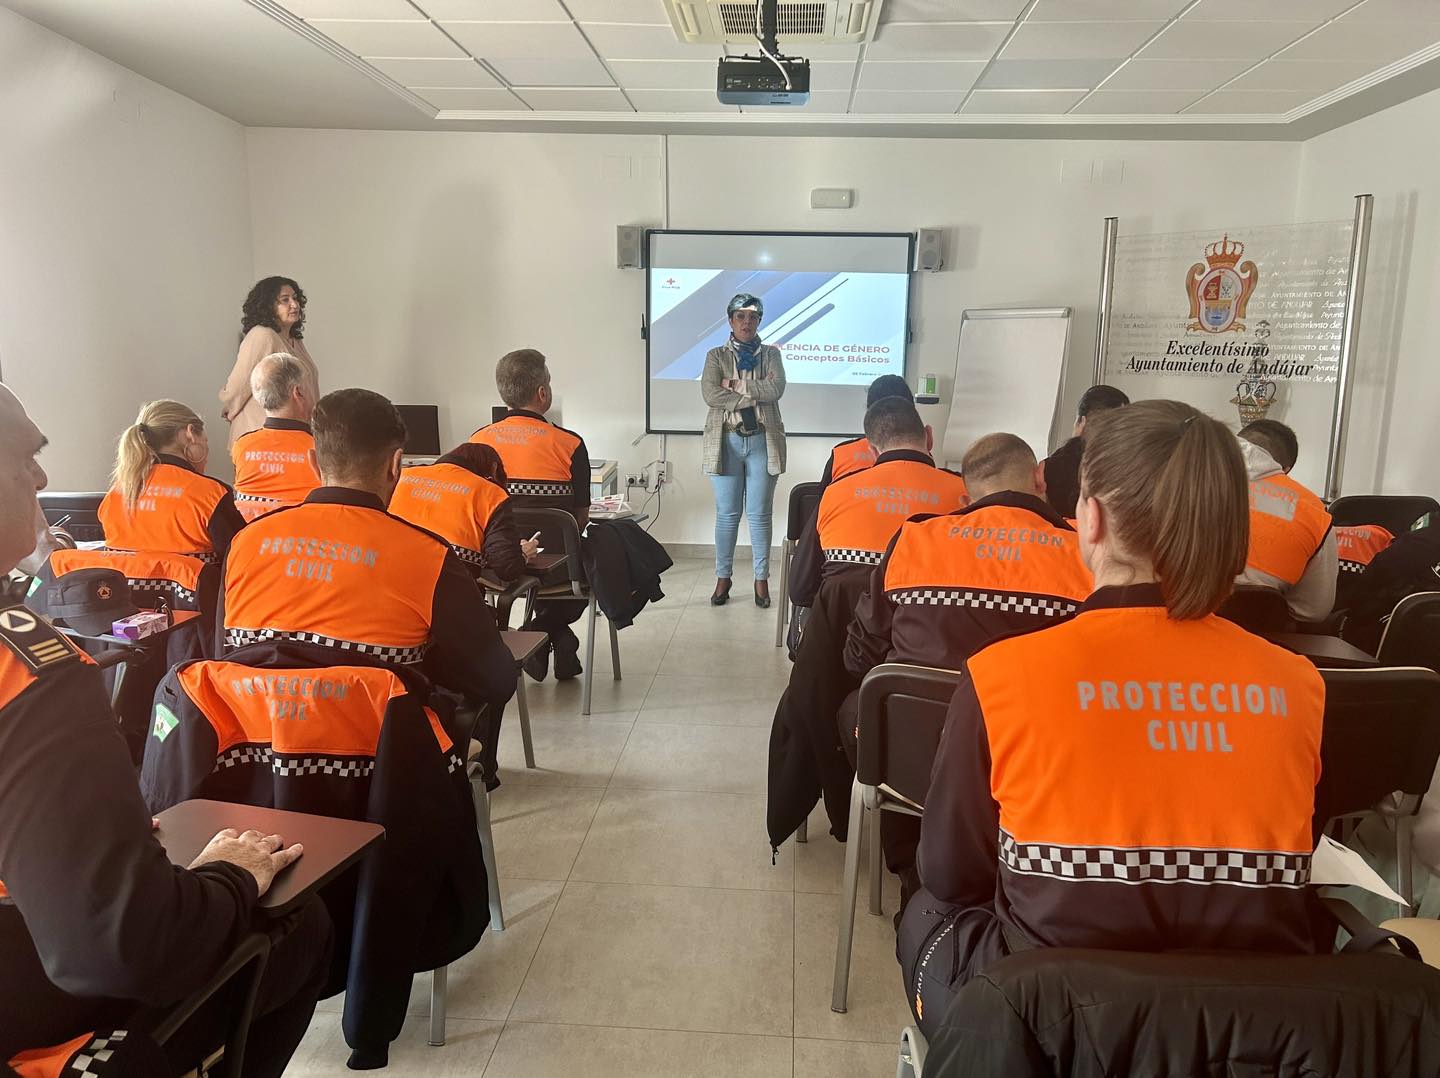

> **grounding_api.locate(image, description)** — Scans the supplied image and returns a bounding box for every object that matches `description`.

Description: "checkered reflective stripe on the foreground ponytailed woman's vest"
[999,830,1310,888]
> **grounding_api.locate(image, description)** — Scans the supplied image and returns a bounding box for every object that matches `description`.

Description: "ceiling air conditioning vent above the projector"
[665,0,884,47]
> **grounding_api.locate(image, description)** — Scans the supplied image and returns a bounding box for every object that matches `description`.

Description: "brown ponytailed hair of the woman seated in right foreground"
[1080,400,1250,619]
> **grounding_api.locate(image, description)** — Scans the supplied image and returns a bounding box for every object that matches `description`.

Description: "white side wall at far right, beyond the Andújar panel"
[1297,91,1440,497]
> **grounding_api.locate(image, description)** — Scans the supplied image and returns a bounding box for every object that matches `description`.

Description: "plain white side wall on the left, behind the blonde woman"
[0,7,252,489]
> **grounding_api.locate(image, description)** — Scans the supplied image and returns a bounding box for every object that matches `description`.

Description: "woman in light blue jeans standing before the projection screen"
[700,292,785,607]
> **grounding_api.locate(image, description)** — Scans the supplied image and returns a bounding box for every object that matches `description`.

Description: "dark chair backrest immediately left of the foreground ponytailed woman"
[855,662,960,805]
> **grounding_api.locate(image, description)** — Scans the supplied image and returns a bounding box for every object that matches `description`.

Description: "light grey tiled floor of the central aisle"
[288,561,909,1078]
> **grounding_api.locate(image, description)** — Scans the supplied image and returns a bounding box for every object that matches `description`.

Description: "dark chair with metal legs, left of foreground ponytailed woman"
[829,662,960,1015]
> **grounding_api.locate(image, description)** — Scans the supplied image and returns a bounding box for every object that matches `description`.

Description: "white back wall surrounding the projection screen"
[246,130,1300,543]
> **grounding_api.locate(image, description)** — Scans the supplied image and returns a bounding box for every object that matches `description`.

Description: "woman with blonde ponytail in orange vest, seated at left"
[99,400,245,563]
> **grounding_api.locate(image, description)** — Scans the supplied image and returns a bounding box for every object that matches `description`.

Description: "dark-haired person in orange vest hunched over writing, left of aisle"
[390,442,540,584]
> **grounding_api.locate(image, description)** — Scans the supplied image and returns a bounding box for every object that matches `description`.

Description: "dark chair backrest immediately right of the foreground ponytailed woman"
[1315,666,1440,829]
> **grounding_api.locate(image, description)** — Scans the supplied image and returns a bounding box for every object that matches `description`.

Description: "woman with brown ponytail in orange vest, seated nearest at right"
[897,400,1325,1035]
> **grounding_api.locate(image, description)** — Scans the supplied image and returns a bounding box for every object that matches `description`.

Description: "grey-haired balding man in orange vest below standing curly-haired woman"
[230,351,320,520]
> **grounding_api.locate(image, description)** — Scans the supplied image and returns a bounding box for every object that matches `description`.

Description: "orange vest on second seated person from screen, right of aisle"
[816,458,965,566]
